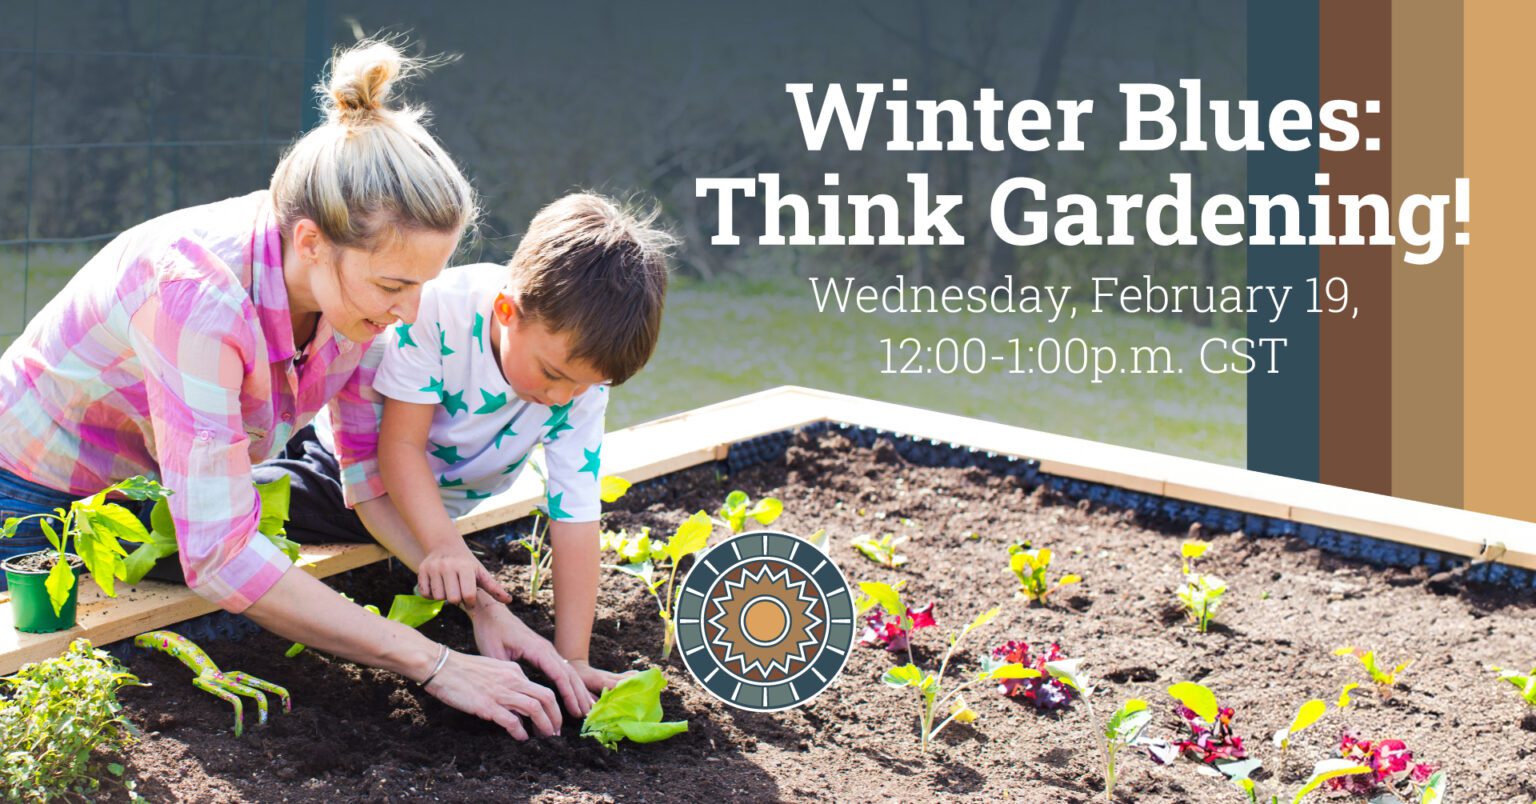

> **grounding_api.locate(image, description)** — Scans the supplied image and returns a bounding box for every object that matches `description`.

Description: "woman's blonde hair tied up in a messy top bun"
[272,40,478,249]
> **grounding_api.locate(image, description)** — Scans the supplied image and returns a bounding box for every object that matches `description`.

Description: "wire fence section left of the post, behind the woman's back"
[0,0,330,347]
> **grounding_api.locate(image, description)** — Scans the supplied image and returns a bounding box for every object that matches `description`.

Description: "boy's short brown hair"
[508,192,677,384]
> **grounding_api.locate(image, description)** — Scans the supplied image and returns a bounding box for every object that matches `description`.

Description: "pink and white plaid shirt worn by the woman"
[0,191,384,612]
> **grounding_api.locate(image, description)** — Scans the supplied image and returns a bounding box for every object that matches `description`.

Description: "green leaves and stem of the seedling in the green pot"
[0,477,170,615]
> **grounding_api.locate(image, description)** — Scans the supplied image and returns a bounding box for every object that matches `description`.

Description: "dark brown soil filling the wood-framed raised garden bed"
[111,434,1536,804]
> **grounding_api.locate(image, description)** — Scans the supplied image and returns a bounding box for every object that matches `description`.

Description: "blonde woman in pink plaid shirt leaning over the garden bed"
[0,43,591,739]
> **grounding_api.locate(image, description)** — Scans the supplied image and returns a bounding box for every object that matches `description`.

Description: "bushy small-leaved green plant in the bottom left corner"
[0,640,143,801]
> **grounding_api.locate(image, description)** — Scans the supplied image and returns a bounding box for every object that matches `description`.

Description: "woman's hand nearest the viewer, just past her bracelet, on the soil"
[427,650,561,739]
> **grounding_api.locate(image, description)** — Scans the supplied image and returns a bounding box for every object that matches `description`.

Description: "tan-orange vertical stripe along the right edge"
[1462,3,1536,520]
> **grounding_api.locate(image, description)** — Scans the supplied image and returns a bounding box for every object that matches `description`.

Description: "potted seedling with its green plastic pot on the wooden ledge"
[0,477,170,633]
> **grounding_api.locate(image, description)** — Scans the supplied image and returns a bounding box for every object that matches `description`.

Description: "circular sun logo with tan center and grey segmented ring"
[677,530,854,712]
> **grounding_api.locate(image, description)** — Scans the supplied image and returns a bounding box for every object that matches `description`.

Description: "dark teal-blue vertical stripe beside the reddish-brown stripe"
[1247,0,1319,480]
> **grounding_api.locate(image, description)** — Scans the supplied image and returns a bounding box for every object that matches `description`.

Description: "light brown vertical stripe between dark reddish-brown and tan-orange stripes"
[1392,2,1465,507]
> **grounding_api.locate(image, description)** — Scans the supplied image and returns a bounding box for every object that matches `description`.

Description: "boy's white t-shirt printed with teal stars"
[324,263,608,523]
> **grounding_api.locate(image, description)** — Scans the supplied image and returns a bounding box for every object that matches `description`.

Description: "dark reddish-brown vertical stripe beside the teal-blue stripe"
[1320,0,1392,493]
